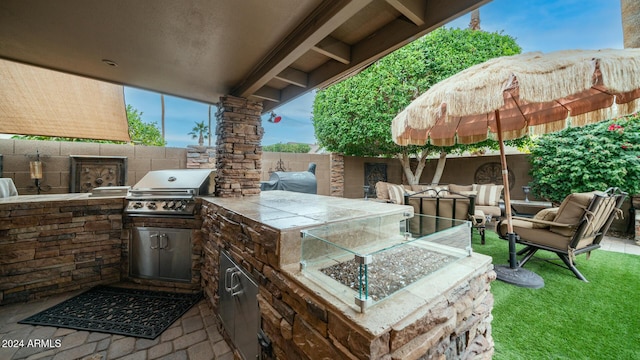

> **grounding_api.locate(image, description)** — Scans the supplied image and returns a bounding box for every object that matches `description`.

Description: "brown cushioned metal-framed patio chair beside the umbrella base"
[496,188,627,281]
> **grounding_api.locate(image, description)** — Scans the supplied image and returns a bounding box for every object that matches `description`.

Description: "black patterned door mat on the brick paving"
[18,286,202,339]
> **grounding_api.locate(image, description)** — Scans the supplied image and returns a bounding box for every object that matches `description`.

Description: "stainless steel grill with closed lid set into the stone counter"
[124,169,212,217]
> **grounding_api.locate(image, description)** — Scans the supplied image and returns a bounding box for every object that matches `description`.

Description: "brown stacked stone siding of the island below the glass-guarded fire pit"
[202,201,495,359]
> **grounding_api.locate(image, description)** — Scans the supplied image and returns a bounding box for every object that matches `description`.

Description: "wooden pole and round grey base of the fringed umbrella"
[494,110,544,289]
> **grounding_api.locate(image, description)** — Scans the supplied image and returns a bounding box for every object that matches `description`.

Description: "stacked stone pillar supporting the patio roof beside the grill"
[215,96,264,197]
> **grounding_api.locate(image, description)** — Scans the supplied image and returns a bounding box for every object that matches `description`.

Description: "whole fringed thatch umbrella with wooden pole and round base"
[392,49,640,287]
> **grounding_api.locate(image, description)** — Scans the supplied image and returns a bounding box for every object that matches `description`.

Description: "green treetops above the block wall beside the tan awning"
[12,104,166,146]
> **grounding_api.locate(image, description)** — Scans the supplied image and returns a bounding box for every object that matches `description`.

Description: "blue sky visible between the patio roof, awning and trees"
[125,0,624,148]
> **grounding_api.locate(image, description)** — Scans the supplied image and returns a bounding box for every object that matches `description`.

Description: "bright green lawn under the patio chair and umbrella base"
[473,231,640,360]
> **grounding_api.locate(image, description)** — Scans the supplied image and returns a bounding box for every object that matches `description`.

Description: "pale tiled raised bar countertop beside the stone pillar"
[203,190,413,230]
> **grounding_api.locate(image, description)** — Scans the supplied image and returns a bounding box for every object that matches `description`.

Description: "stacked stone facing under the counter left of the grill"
[0,198,123,304]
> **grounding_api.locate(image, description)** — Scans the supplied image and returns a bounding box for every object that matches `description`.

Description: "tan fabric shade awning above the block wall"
[0,60,131,142]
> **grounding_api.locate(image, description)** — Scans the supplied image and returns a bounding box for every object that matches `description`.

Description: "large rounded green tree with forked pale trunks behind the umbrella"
[313,28,521,184]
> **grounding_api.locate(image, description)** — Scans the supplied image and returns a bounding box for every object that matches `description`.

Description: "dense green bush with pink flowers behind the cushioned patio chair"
[529,113,640,202]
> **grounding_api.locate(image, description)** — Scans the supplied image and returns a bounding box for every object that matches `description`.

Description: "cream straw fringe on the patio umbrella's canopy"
[392,49,640,146]
